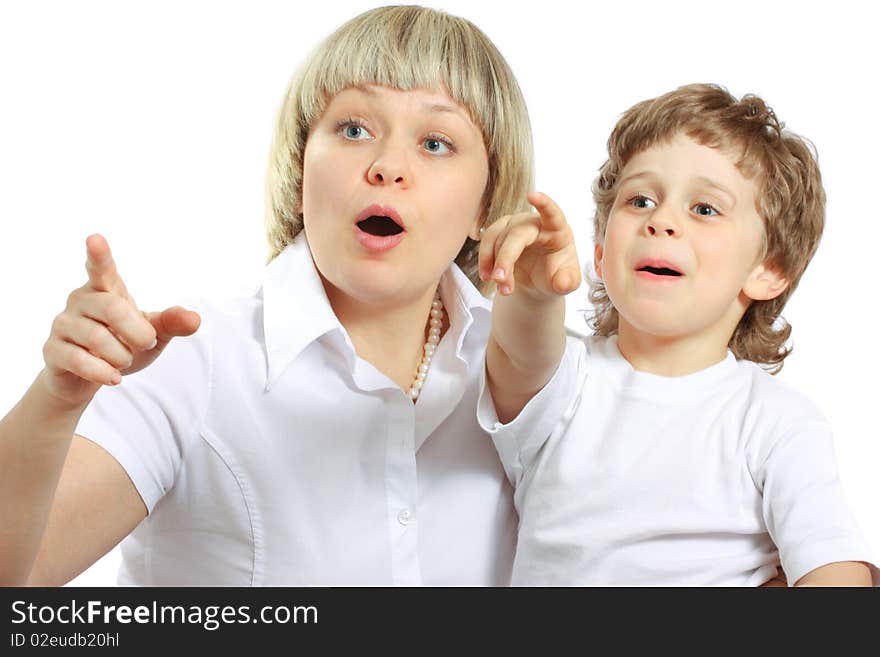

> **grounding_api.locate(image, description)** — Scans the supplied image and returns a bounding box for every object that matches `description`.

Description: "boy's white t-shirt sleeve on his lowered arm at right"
[755,418,878,585]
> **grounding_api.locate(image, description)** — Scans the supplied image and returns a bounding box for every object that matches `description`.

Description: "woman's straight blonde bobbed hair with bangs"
[265,6,534,287]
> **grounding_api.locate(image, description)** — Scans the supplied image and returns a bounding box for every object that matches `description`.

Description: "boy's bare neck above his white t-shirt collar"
[617,318,730,376]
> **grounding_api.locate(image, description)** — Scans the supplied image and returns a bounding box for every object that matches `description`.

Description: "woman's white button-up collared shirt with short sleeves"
[77,239,516,586]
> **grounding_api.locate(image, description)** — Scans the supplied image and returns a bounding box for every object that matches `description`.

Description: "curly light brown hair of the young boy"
[589,84,825,374]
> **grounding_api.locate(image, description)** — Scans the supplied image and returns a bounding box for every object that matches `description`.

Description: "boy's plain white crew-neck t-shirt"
[479,337,877,586]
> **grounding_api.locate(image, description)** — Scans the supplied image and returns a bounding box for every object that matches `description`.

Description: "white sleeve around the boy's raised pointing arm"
[477,336,586,486]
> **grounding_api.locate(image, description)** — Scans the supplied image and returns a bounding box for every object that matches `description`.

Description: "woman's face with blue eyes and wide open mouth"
[302,85,489,306]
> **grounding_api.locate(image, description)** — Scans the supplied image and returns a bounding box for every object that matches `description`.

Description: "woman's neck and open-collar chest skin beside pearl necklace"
[323,280,448,390]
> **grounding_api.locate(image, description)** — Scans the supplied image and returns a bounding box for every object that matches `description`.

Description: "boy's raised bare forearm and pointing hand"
[480,193,581,423]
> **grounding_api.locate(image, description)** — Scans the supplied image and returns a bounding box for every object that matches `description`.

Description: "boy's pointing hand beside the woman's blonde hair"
[479,192,582,295]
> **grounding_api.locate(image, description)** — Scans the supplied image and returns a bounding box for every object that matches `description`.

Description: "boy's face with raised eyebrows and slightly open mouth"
[596,134,786,350]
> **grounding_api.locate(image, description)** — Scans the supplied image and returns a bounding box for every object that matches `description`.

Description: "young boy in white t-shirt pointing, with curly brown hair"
[480,85,876,585]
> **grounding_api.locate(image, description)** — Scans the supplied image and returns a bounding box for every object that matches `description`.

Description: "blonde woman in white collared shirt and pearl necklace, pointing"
[0,7,532,585]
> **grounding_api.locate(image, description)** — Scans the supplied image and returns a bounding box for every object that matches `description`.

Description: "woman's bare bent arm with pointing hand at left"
[0,236,200,586]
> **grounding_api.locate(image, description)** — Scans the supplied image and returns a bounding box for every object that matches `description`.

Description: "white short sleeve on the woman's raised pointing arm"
[76,304,211,513]
